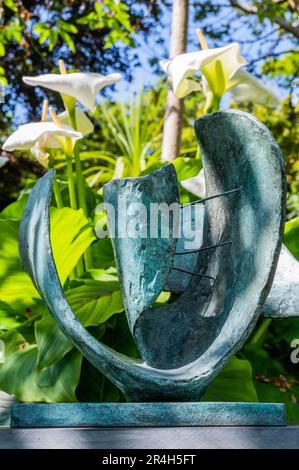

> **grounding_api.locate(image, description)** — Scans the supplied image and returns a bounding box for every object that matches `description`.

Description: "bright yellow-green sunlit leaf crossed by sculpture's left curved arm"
[0,206,95,314]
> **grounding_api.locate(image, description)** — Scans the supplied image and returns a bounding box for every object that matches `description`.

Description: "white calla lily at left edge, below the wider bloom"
[2,121,83,166]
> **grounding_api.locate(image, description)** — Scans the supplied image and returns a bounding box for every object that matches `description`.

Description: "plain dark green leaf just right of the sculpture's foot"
[203,356,258,402]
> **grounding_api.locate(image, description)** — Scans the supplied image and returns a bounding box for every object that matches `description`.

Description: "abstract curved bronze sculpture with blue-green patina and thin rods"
[13,111,298,425]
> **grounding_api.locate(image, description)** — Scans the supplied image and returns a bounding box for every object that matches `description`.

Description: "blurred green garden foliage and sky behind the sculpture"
[0,0,299,423]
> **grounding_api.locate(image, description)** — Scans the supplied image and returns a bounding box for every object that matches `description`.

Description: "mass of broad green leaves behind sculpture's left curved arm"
[0,198,123,402]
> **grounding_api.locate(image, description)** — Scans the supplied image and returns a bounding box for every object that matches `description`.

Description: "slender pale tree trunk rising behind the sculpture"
[162,0,189,161]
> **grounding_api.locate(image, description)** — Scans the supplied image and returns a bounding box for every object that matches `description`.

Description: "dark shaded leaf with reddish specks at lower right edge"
[242,344,299,423]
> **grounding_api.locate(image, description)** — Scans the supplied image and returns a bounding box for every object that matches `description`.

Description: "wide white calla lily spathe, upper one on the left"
[23,72,121,111]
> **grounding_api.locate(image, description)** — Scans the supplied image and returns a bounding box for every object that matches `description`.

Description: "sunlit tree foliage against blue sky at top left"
[0,0,168,116]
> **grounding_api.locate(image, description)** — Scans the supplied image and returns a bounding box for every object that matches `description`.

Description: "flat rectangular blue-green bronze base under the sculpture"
[11,402,286,428]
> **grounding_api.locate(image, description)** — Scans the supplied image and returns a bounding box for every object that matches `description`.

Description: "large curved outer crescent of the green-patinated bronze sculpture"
[20,108,285,406]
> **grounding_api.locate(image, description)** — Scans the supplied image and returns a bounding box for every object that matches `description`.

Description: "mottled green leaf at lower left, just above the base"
[0,331,82,403]
